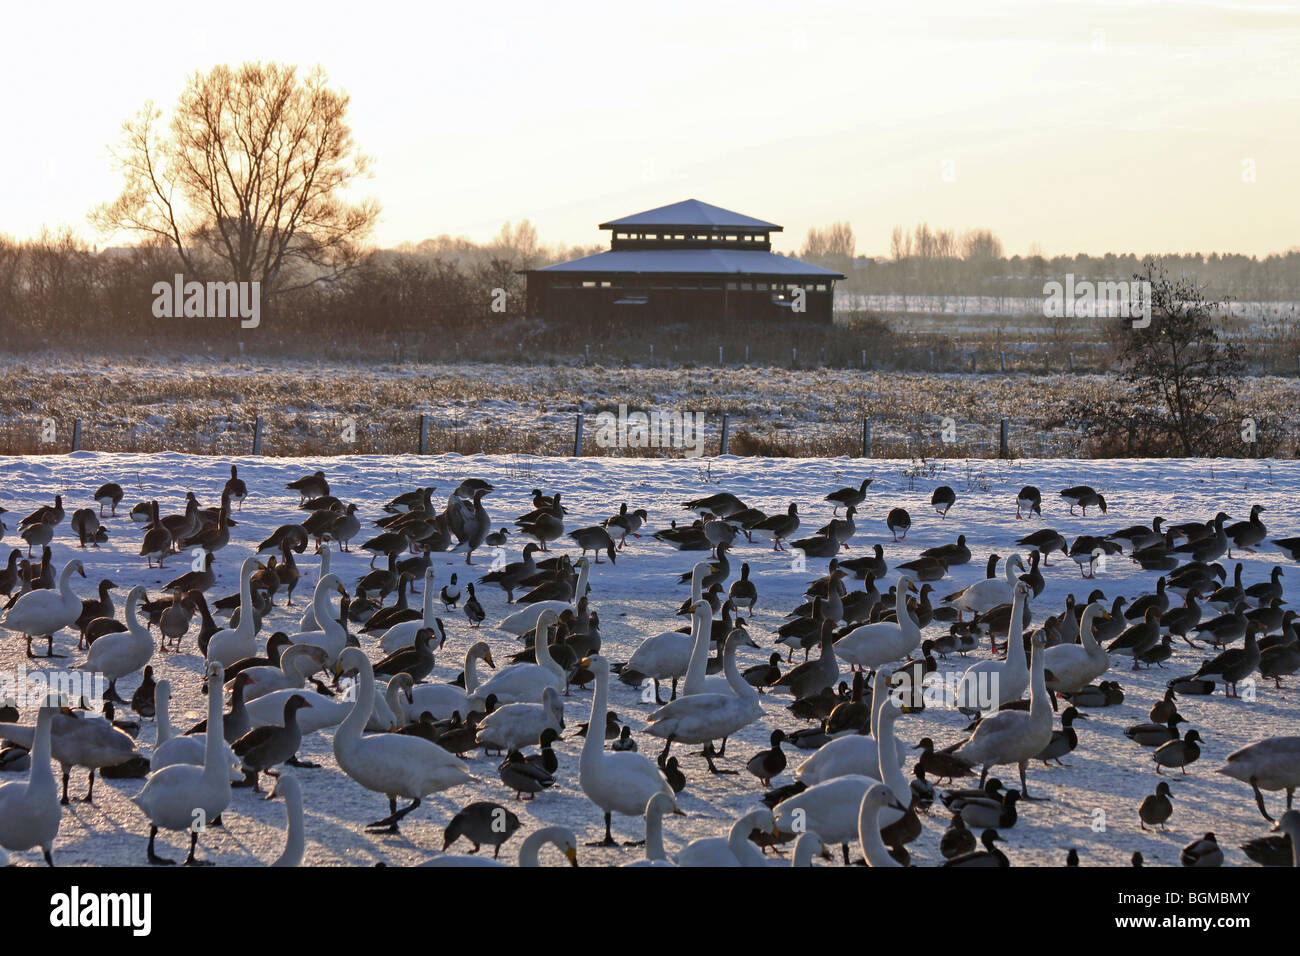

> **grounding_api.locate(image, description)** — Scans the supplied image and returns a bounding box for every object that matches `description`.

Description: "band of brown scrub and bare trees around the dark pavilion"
[0,222,1300,361]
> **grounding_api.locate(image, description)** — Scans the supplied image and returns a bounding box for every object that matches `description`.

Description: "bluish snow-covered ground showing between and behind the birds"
[0,453,1300,866]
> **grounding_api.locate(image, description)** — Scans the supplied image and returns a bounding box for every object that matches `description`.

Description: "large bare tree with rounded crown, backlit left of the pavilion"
[91,62,380,298]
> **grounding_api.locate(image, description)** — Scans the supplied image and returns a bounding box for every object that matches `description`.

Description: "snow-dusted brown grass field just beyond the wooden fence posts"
[0,359,1300,458]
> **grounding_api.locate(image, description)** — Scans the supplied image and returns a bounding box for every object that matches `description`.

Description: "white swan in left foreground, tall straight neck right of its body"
[133,660,233,865]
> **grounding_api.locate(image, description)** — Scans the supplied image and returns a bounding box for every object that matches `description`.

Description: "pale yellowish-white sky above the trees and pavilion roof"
[0,0,1300,255]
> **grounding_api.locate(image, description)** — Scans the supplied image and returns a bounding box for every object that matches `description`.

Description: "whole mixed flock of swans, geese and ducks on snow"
[0,455,1300,866]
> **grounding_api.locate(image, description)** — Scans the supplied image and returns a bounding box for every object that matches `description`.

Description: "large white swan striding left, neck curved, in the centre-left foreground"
[334,648,471,832]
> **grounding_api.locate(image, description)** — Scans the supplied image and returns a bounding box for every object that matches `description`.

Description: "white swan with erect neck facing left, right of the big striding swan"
[579,656,676,847]
